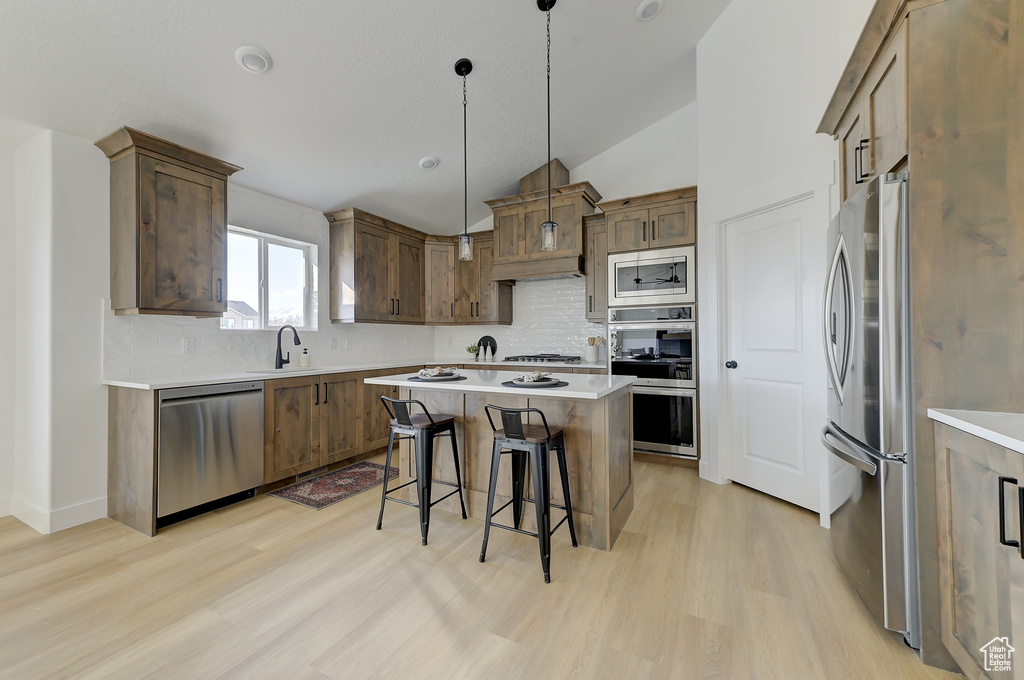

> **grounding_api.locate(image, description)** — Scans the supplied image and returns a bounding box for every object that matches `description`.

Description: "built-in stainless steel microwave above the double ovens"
[608,246,696,307]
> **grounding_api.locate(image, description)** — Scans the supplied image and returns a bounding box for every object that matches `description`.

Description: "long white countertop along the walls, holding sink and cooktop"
[103,358,607,389]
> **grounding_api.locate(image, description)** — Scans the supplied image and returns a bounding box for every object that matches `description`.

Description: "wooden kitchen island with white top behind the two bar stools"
[365,371,633,550]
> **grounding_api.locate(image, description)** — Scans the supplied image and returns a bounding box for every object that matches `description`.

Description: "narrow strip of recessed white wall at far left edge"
[0,146,15,517]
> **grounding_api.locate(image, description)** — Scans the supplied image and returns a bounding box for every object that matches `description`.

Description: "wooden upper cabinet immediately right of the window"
[326,208,426,324]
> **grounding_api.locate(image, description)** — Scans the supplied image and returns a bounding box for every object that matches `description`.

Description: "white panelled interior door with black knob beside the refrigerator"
[722,197,828,512]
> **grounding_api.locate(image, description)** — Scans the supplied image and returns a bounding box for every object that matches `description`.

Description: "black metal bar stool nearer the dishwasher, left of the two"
[377,396,466,545]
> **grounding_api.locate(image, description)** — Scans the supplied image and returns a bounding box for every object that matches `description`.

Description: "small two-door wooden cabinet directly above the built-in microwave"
[599,186,697,253]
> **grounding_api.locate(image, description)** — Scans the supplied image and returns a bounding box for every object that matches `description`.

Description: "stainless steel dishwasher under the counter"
[157,381,263,524]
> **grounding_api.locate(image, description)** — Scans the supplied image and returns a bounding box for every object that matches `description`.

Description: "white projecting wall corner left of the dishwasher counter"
[10,131,110,534]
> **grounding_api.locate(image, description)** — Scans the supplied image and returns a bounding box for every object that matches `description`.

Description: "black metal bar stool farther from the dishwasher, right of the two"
[480,403,579,583]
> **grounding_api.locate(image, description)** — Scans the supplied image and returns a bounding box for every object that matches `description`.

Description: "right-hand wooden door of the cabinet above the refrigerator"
[865,22,907,176]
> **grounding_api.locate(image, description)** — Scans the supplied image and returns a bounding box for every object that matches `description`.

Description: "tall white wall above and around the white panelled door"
[697,0,843,499]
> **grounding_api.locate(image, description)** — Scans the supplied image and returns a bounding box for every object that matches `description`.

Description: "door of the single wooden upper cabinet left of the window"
[138,156,227,313]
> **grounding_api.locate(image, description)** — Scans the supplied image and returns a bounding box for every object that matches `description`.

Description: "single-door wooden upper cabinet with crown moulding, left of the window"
[96,127,242,316]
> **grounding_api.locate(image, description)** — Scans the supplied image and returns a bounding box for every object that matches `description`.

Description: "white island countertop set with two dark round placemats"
[364,370,634,399]
